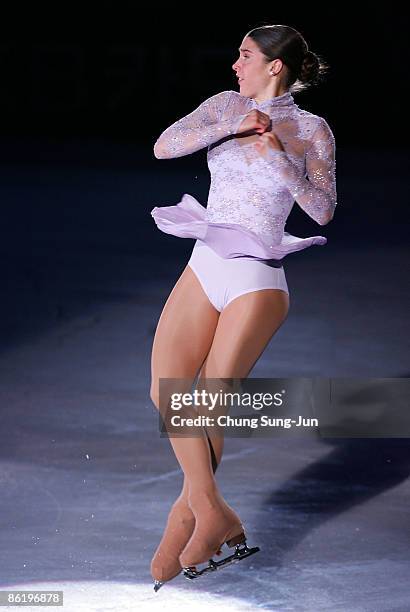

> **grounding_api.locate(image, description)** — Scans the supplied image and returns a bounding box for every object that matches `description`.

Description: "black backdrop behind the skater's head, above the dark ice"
[0,1,408,149]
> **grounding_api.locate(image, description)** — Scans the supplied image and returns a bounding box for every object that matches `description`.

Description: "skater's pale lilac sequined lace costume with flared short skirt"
[151,91,337,310]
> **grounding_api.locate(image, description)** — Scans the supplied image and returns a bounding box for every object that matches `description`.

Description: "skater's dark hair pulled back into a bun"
[246,25,329,93]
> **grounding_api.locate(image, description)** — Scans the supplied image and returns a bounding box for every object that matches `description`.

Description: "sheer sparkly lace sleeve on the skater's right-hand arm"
[262,118,337,225]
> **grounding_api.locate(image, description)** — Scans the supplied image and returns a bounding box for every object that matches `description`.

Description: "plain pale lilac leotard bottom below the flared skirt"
[188,240,289,312]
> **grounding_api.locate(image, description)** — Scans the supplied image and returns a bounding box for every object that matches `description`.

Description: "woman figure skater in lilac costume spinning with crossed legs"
[151,25,336,590]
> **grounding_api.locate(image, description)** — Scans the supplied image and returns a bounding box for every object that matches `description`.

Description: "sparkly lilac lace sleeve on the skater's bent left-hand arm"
[154,91,246,159]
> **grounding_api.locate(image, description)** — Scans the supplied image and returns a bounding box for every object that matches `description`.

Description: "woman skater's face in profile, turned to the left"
[232,36,282,98]
